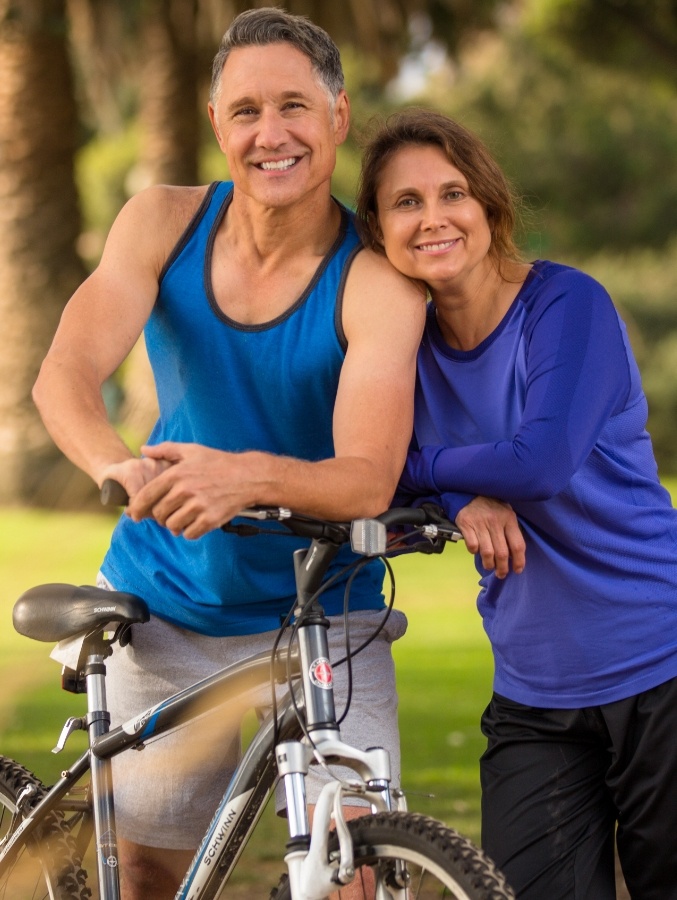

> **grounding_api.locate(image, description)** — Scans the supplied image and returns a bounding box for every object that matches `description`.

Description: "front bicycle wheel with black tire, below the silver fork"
[270,812,515,900]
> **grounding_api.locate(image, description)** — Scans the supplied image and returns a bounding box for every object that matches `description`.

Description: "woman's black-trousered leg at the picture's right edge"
[601,679,677,900]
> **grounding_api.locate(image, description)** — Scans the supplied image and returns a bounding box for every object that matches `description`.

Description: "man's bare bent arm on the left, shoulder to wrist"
[33,188,198,493]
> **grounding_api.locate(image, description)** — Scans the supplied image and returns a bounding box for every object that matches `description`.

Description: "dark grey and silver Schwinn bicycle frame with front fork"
[0,539,402,900]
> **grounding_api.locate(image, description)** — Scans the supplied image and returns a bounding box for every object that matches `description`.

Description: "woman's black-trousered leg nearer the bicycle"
[480,695,615,900]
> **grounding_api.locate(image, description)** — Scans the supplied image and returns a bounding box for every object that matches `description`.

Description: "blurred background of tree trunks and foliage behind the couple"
[0,0,677,507]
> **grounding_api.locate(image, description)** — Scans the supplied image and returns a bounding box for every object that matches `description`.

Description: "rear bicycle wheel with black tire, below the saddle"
[0,757,92,900]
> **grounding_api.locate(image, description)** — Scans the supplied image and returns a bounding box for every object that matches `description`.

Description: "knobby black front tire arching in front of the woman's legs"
[271,813,515,900]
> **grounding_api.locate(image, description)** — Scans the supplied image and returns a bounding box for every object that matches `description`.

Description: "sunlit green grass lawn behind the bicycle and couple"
[0,509,491,892]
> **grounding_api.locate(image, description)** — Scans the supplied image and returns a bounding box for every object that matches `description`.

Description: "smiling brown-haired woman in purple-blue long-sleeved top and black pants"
[357,110,677,900]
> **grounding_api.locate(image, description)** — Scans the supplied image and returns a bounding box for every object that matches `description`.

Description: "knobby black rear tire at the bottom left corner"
[0,757,92,900]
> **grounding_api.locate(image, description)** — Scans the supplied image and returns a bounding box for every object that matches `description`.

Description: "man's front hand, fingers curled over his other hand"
[127,441,265,539]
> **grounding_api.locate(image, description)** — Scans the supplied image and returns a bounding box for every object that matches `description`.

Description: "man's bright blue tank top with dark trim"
[102,182,384,636]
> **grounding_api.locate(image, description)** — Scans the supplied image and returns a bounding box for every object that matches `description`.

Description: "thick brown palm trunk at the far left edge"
[0,0,95,504]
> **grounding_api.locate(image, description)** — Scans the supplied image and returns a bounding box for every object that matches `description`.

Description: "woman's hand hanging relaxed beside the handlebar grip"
[456,497,526,578]
